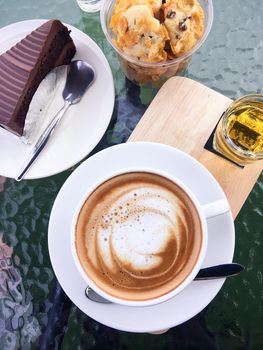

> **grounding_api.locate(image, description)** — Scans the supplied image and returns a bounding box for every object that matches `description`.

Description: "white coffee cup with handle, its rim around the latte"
[71,167,230,306]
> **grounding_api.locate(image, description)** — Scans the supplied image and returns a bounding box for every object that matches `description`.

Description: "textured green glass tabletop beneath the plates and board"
[0,0,263,350]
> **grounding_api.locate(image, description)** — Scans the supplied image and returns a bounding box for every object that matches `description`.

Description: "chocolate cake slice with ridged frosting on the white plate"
[0,20,76,136]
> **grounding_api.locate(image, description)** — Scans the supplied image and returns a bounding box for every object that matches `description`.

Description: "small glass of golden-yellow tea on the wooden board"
[213,94,263,165]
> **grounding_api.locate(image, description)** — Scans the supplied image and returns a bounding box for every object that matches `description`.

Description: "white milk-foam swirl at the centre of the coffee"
[93,189,187,288]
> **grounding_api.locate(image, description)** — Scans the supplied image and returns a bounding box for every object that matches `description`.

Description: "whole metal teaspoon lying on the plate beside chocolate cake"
[16,60,95,181]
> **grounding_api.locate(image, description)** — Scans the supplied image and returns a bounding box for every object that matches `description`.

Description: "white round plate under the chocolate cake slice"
[0,20,114,179]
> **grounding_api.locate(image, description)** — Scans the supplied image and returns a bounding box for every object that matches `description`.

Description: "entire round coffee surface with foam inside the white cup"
[75,172,202,301]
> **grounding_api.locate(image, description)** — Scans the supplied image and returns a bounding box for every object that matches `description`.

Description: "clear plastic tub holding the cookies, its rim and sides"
[100,0,213,87]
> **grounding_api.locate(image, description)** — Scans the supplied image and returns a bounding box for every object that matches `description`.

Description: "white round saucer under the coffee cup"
[48,142,235,332]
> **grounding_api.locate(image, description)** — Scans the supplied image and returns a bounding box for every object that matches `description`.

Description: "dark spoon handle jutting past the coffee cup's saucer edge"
[195,263,244,280]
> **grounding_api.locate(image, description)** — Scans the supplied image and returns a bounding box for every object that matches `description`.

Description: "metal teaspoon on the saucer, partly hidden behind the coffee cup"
[85,263,245,304]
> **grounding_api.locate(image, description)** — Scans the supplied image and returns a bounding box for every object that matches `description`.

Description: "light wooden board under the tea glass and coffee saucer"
[128,77,263,218]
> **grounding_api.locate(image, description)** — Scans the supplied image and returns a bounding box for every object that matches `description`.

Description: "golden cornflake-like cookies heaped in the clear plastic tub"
[110,0,204,62]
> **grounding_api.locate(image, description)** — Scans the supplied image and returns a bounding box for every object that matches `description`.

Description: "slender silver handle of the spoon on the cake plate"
[16,101,70,181]
